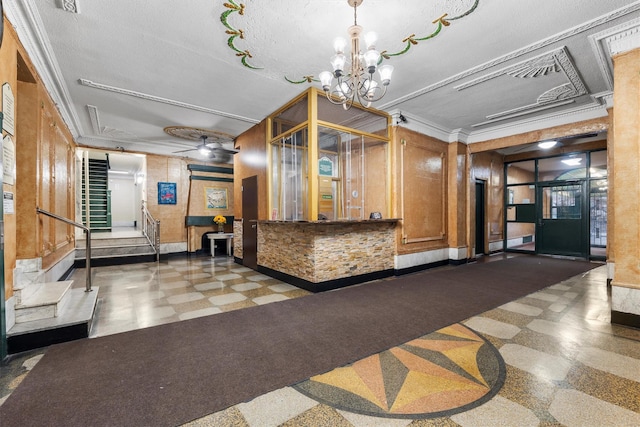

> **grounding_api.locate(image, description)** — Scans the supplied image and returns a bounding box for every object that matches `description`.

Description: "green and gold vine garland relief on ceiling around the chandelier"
[220,0,480,84]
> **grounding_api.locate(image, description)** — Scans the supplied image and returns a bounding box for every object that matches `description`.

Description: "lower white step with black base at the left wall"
[7,287,99,354]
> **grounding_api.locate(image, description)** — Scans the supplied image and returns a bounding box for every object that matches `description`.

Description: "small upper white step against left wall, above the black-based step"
[15,280,73,323]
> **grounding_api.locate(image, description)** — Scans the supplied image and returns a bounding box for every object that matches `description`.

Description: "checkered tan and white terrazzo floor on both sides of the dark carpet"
[0,257,640,427]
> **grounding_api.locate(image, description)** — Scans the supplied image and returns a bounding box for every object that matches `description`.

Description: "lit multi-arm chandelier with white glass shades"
[318,0,393,110]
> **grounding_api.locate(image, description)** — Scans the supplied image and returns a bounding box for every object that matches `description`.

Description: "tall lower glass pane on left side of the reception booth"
[271,128,307,221]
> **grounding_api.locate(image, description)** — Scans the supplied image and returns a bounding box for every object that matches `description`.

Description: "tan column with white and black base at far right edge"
[609,48,640,327]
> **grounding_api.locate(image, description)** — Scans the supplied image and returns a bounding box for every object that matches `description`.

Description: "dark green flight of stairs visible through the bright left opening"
[82,159,111,232]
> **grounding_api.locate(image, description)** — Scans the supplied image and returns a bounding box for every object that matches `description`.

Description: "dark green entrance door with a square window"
[536,182,588,258]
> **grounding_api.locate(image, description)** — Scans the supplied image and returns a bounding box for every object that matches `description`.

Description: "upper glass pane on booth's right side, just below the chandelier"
[318,94,388,138]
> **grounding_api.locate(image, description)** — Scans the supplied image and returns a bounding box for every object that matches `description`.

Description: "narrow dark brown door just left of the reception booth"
[242,175,258,270]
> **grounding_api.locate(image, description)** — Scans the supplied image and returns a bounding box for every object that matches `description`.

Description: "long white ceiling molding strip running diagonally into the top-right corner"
[379,1,640,109]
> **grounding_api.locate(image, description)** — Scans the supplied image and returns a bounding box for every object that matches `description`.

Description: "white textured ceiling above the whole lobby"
[4,0,640,166]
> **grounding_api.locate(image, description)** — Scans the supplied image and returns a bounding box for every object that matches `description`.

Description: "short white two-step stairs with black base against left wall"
[7,268,98,354]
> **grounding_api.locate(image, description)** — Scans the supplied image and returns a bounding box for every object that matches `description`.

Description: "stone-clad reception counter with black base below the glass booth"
[257,219,399,292]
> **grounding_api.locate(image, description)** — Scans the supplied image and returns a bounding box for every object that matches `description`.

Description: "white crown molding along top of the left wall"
[4,0,84,138]
